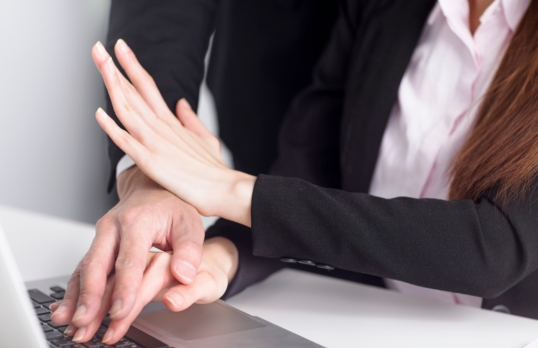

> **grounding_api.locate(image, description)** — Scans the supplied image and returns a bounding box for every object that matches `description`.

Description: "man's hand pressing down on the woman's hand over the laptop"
[52,167,204,328]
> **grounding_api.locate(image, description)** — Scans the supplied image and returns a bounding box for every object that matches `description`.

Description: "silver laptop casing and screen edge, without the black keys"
[0,222,321,348]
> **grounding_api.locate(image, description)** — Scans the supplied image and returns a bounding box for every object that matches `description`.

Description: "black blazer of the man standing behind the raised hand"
[106,0,338,191]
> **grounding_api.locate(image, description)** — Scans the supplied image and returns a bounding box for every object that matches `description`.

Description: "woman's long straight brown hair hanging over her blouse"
[449,0,538,202]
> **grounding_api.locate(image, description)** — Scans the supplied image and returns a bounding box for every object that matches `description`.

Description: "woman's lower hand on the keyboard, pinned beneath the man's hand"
[51,237,238,344]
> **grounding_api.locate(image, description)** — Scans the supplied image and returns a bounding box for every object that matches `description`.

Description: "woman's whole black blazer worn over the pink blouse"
[207,0,538,318]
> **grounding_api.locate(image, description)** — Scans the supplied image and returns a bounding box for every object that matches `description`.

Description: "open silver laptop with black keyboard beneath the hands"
[0,222,321,348]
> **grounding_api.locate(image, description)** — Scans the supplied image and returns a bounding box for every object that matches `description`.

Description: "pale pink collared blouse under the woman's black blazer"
[370,0,530,307]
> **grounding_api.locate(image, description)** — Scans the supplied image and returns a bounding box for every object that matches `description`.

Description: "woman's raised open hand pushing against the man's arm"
[93,40,256,226]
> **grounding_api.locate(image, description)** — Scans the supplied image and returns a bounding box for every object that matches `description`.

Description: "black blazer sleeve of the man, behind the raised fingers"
[106,0,219,192]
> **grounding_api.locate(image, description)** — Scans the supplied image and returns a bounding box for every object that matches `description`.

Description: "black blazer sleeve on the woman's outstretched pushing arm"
[248,175,538,298]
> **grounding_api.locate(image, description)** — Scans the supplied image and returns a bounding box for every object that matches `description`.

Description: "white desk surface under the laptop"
[0,206,538,348]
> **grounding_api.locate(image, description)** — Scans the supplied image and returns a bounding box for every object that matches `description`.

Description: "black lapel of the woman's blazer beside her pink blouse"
[340,0,436,192]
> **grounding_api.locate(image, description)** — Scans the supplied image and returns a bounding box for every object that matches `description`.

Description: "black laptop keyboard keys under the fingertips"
[28,286,170,348]
